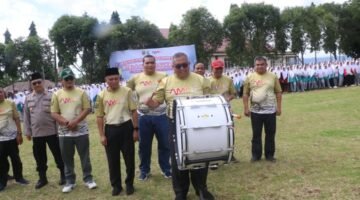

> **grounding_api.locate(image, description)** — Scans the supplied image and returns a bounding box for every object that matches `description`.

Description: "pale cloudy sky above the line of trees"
[0,0,345,42]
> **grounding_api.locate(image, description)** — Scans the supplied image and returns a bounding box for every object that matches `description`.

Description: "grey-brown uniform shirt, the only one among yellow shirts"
[24,92,57,137]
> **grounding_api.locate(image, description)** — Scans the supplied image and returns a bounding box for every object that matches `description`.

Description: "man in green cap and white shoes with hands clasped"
[51,68,97,193]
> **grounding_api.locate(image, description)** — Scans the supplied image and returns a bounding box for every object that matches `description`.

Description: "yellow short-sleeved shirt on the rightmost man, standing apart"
[244,72,281,114]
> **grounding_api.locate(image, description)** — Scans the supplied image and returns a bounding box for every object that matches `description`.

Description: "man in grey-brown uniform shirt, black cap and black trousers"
[24,72,65,189]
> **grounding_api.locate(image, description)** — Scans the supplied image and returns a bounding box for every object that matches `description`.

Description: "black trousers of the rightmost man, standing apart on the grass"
[251,112,276,159]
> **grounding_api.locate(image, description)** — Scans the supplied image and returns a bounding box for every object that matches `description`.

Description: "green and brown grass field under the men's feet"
[0,87,360,200]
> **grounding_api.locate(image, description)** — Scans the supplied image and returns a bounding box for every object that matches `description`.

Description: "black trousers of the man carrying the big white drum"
[168,118,208,200]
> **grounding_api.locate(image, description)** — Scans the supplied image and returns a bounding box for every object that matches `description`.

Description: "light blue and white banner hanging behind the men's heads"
[110,45,196,80]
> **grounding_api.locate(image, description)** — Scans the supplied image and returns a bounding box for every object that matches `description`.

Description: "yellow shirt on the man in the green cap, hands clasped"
[50,88,90,136]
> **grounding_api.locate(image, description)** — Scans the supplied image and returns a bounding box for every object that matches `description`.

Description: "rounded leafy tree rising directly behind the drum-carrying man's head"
[169,7,223,64]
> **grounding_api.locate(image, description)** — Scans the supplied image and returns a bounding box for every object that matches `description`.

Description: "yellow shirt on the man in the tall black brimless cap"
[95,87,136,125]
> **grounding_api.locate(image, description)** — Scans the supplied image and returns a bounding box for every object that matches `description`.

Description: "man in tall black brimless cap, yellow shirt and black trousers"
[95,68,138,196]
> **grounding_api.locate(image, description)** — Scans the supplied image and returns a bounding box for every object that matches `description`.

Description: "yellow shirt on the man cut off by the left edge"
[0,99,19,141]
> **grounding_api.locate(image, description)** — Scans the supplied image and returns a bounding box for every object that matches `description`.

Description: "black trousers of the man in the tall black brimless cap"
[105,120,135,189]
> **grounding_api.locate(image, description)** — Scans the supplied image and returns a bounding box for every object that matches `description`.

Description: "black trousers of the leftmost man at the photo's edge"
[0,139,23,186]
